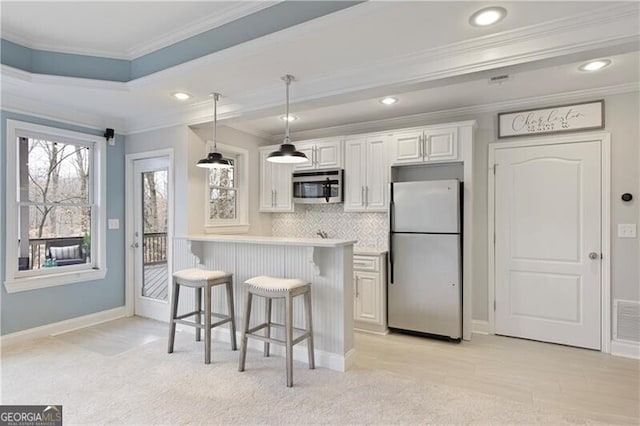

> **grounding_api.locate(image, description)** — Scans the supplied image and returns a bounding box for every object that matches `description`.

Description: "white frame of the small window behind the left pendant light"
[204,141,249,234]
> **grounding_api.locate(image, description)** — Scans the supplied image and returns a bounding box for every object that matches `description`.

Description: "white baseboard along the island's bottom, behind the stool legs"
[176,325,356,372]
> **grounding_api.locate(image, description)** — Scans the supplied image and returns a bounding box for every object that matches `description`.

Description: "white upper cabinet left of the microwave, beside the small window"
[259,146,293,212]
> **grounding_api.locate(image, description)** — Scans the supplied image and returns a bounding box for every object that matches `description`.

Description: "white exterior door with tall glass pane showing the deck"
[133,157,171,321]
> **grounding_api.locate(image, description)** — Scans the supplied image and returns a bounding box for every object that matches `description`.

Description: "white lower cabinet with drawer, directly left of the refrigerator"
[353,254,387,333]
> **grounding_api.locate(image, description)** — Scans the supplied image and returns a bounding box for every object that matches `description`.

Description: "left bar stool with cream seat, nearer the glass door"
[168,269,237,364]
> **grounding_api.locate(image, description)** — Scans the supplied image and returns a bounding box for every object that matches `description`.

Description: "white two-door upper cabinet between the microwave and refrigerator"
[344,135,389,212]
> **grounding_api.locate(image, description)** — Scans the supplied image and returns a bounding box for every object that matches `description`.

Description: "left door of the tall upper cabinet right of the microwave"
[343,138,367,212]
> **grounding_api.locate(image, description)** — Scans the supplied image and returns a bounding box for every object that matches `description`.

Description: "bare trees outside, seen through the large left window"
[18,137,93,269]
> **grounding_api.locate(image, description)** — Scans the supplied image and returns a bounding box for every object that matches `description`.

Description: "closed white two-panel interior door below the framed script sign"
[495,141,602,349]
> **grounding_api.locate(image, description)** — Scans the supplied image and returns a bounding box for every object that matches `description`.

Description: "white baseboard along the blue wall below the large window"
[0,306,127,347]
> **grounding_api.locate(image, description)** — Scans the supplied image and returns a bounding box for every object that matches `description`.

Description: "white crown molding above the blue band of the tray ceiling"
[2,0,282,60]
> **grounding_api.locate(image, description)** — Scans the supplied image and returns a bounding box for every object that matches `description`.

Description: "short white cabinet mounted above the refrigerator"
[391,127,460,164]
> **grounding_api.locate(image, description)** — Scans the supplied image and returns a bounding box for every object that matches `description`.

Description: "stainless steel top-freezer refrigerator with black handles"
[387,180,462,339]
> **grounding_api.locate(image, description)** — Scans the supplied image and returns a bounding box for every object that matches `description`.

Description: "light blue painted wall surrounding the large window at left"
[0,111,125,335]
